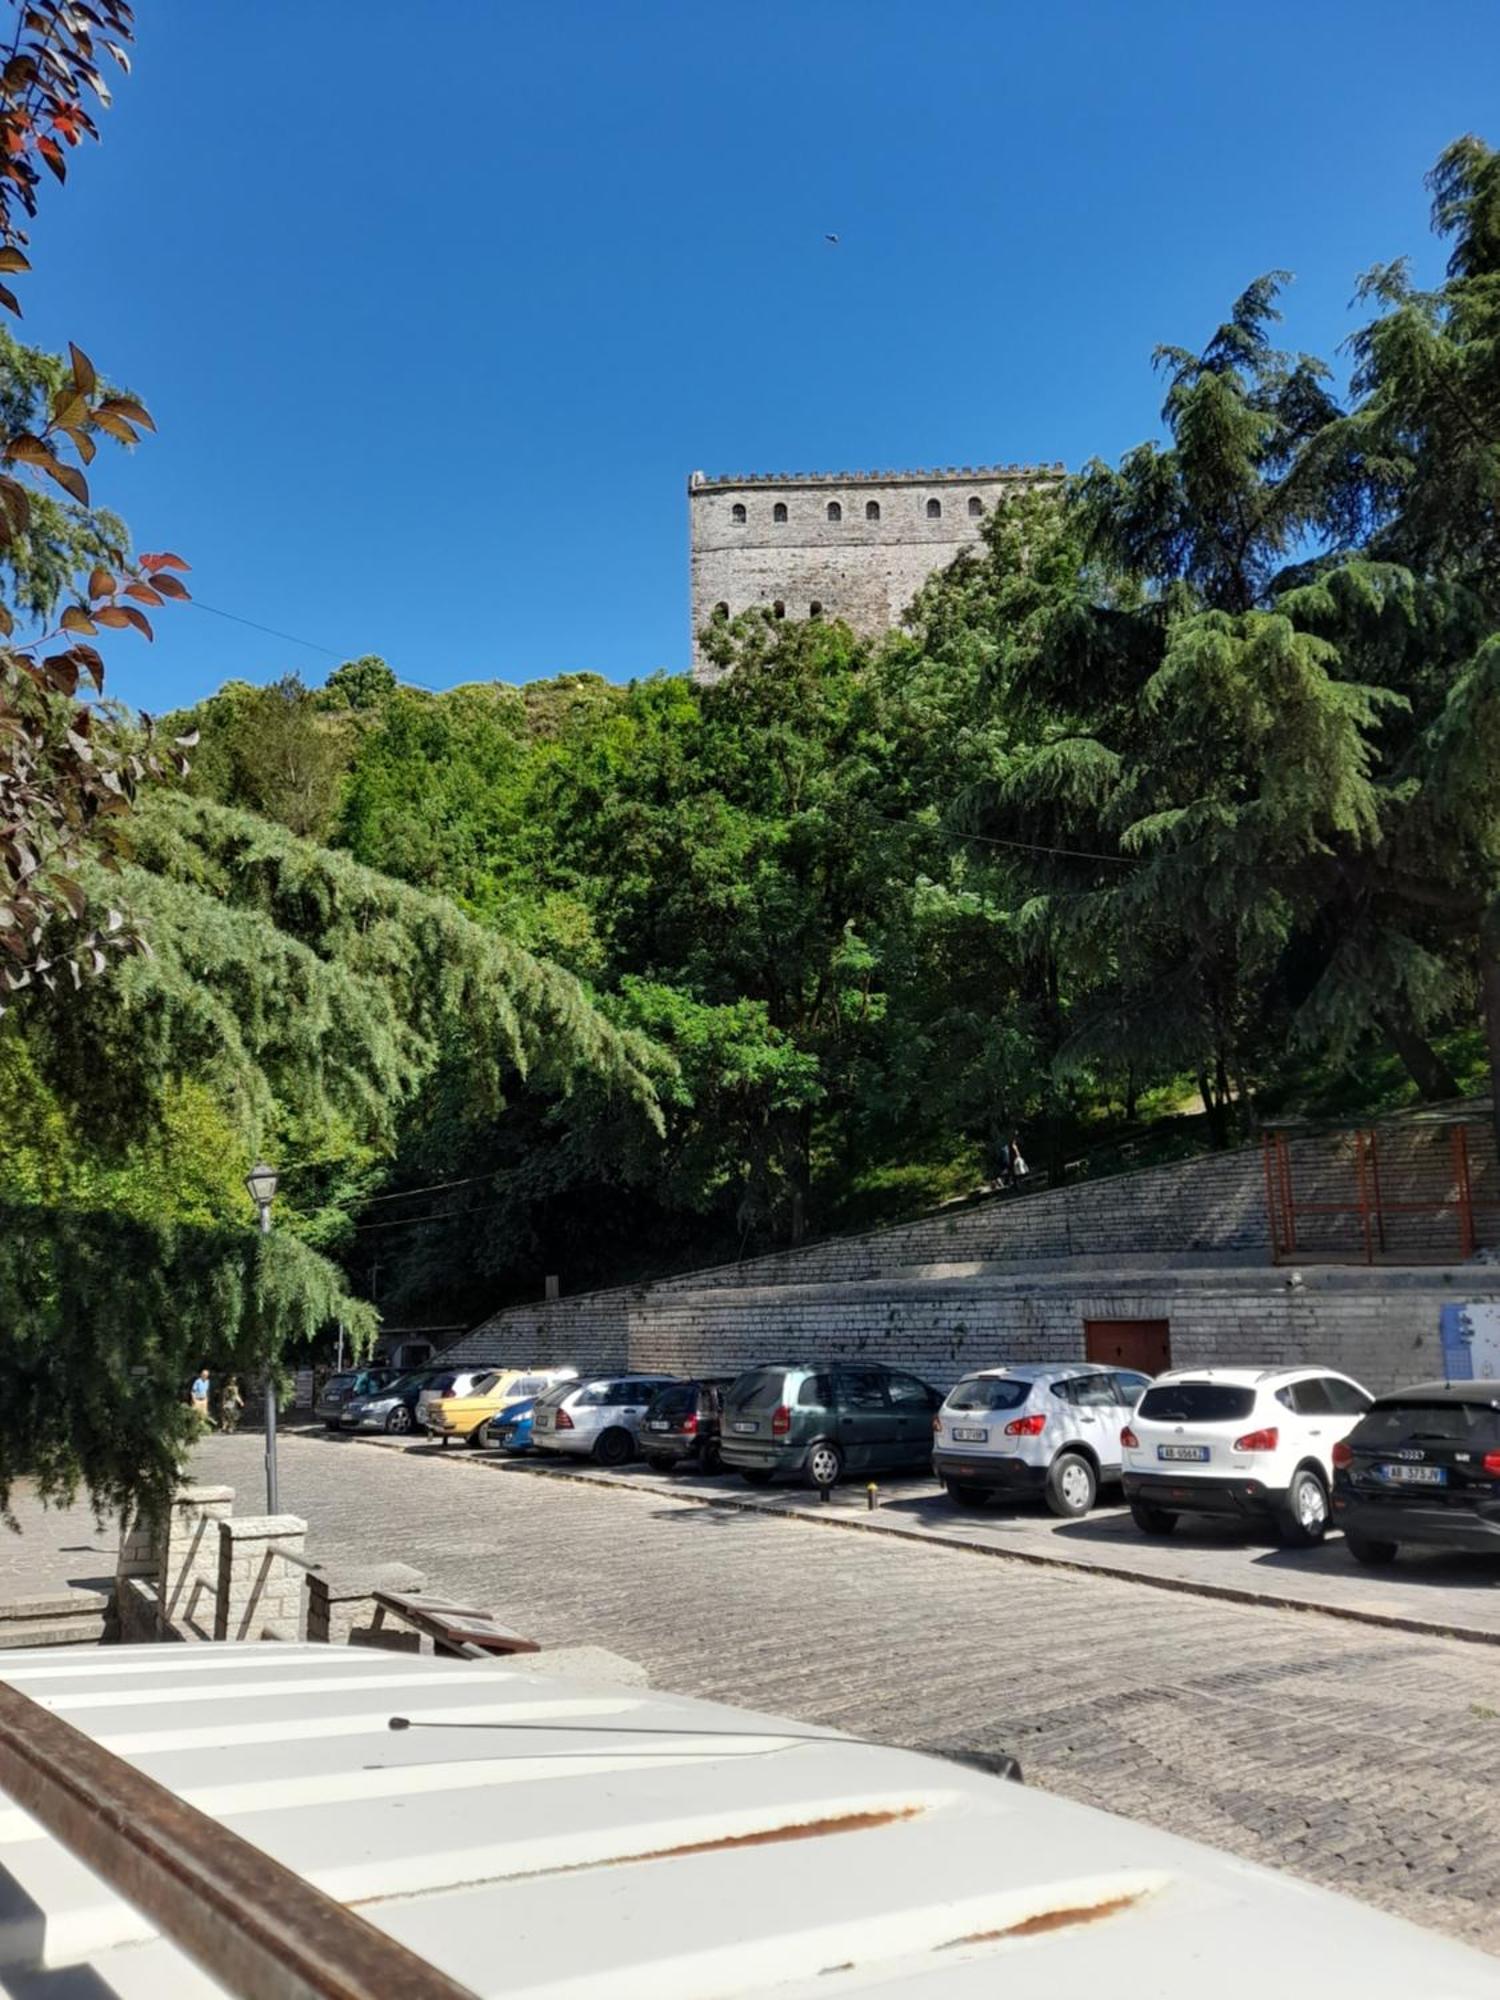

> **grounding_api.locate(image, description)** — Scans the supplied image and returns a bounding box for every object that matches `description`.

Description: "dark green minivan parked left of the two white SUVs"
[720,1362,942,1486]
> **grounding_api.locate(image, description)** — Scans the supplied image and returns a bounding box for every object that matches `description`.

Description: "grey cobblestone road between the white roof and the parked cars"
[194,1434,1500,1952]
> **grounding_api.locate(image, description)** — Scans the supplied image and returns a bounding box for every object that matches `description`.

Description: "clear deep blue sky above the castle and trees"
[22,0,1500,710]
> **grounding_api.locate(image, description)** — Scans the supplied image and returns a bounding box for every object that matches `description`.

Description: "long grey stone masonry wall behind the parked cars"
[450,1126,1500,1388]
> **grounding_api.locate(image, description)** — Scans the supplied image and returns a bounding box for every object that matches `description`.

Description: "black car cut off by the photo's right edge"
[1334,1382,1500,1562]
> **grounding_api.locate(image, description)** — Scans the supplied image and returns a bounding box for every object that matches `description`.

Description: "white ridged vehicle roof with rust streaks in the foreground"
[0,1644,1500,2000]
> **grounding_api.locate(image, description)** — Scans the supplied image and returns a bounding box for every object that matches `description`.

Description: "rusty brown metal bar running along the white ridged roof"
[0,1682,474,2000]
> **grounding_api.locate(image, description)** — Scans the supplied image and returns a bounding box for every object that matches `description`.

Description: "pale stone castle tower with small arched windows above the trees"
[688,464,1062,680]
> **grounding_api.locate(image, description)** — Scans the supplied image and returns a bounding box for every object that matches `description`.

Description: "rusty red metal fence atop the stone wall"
[1264,1114,1500,1264]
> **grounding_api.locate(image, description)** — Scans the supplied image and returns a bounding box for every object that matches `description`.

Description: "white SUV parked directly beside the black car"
[1120,1368,1372,1548]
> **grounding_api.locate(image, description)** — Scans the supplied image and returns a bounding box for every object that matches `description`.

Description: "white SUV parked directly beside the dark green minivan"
[932,1362,1150,1518]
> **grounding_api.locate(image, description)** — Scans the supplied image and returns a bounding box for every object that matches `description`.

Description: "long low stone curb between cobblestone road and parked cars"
[356,1434,1500,1646]
